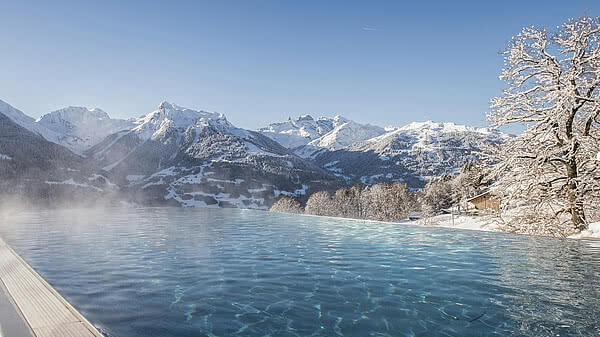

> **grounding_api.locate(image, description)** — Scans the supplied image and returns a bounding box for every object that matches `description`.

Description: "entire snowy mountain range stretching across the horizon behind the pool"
[0,97,508,208]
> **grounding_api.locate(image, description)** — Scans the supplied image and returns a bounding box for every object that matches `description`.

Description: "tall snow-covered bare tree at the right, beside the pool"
[488,17,600,231]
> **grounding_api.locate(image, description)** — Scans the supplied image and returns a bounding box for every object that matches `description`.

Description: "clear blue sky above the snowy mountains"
[0,0,600,128]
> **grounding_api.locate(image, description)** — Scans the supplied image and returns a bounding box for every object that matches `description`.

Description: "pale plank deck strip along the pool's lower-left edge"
[0,238,103,337]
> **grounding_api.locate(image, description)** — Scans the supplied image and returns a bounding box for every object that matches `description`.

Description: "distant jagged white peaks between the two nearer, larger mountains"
[258,115,385,153]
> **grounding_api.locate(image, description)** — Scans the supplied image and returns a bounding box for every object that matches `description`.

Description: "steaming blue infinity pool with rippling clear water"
[0,208,600,337]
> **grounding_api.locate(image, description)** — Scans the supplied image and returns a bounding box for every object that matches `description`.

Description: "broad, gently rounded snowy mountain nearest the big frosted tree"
[313,121,510,187]
